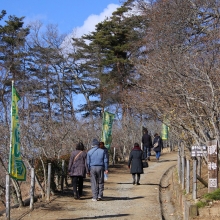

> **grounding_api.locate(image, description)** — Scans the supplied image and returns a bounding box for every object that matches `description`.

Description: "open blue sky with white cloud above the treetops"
[0,0,121,34]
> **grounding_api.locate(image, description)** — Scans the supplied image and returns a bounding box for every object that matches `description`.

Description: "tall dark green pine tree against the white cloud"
[71,1,147,115]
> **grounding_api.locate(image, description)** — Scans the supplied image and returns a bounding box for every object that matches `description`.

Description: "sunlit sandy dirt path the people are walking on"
[0,153,177,220]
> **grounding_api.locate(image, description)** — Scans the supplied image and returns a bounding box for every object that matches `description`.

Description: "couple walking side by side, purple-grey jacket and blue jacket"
[68,139,108,201]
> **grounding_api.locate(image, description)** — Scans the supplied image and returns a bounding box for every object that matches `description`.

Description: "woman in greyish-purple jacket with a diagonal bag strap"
[68,142,89,199]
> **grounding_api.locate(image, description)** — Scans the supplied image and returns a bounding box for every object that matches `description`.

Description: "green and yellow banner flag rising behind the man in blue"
[101,112,115,149]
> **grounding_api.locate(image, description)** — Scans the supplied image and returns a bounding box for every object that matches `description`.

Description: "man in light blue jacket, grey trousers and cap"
[87,138,108,202]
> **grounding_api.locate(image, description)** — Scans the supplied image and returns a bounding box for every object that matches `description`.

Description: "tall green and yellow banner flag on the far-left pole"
[8,83,26,181]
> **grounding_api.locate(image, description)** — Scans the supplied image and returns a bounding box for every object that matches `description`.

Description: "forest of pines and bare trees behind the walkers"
[0,0,220,208]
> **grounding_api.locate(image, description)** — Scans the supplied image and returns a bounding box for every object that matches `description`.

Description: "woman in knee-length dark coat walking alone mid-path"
[128,143,143,185]
